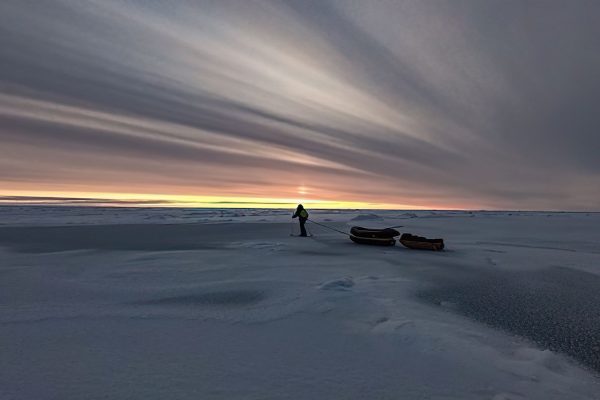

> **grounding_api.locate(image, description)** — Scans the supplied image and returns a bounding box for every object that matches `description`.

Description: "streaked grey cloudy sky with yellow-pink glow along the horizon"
[0,0,600,211]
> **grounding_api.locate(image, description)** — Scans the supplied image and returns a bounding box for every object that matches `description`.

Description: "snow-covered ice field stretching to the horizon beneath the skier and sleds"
[0,206,600,400]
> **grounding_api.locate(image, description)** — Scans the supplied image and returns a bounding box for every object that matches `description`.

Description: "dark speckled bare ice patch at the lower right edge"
[417,267,600,372]
